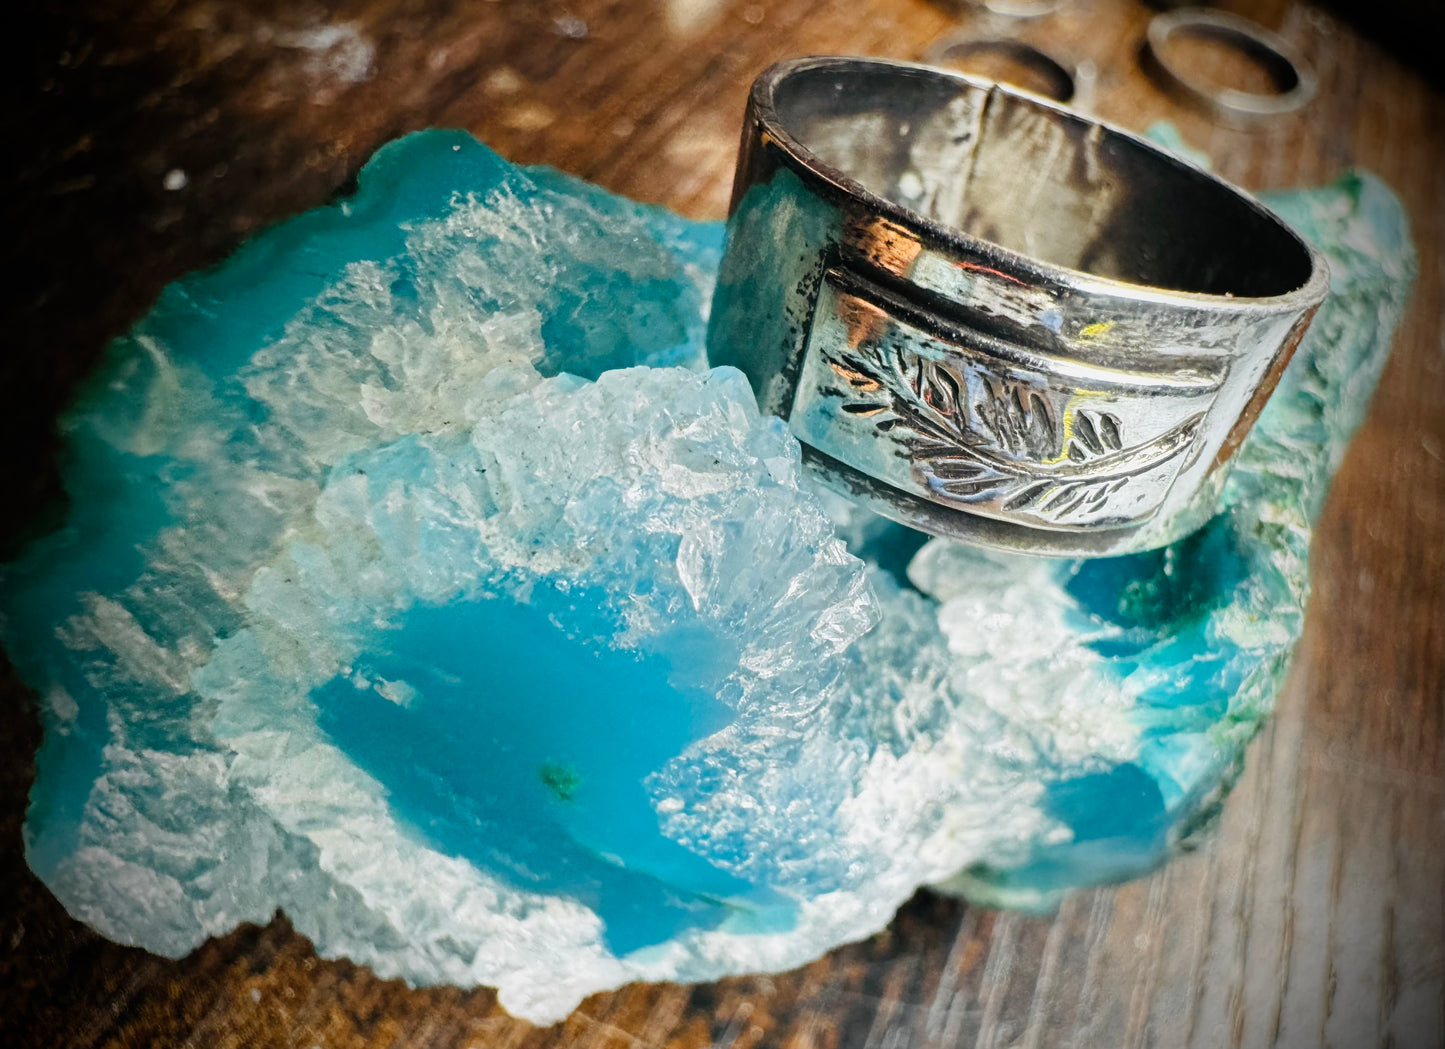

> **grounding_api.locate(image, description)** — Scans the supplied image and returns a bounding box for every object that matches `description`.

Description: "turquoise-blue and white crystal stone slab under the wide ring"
[0,131,1413,1020]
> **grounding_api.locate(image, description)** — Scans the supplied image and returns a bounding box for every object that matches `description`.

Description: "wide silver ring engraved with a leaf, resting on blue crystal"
[708,58,1328,555]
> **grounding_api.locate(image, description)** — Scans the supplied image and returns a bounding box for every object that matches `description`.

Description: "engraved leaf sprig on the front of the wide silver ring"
[831,344,1204,523]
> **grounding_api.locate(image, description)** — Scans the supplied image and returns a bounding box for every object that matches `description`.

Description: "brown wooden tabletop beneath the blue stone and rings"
[0,0,1445,1049]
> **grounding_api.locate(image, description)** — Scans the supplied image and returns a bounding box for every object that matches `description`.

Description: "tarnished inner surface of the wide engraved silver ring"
[773,61,1312,298]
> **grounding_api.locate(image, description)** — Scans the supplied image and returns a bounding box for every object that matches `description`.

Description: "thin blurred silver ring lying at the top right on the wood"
[1144,7,1318,120]
